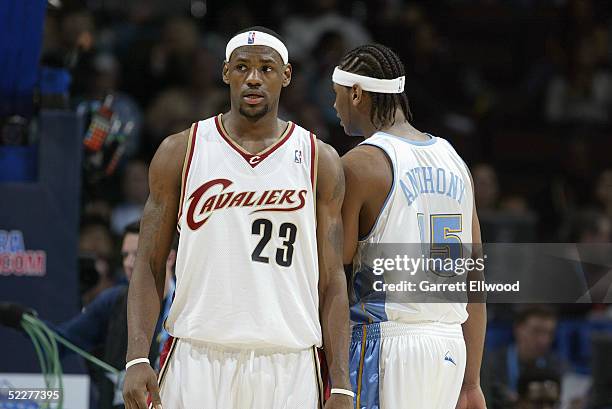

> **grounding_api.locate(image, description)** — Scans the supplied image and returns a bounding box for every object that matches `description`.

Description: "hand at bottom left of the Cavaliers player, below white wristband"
[123,364,162,409]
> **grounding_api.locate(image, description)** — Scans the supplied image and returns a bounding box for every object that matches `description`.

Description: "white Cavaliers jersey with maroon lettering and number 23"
[166,115,321,349]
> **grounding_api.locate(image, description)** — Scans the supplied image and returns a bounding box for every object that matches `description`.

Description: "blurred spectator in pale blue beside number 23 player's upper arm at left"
[111,159,149,233]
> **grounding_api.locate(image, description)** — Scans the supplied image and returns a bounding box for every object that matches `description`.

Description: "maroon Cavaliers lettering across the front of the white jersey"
[186,179,308,231]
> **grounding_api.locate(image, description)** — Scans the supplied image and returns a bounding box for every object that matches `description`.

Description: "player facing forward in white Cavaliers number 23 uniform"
[124,27,353,409]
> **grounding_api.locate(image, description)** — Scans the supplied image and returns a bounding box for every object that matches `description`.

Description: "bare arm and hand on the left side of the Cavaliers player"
[123,130,189,409]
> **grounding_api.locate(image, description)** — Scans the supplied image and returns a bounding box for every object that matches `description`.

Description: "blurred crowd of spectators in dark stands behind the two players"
[4,0,612,408]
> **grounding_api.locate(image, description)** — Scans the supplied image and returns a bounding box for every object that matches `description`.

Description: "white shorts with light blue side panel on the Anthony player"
[350,322,466,409]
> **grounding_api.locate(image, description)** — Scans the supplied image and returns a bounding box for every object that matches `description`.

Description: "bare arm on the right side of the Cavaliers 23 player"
[316,141,353,408]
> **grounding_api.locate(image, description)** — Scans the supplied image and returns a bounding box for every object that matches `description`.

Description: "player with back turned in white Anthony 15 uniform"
[333,45,486,409]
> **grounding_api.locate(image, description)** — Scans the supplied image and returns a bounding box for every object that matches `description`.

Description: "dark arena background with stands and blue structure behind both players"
[0,0,612,409]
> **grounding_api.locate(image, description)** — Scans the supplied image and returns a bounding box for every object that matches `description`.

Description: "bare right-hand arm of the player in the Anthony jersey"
[457,197,487,409]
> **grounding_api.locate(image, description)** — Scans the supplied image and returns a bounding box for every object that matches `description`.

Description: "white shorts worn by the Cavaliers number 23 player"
[159,339,322,409]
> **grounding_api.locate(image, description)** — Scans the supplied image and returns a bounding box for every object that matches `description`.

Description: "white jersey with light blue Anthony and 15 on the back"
[351,132,474,324]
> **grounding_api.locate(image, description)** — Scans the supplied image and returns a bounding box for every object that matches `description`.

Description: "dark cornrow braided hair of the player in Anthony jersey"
[338,44,412,129]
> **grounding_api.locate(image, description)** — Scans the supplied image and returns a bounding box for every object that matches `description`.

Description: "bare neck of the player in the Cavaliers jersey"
[222,110,286,140]
